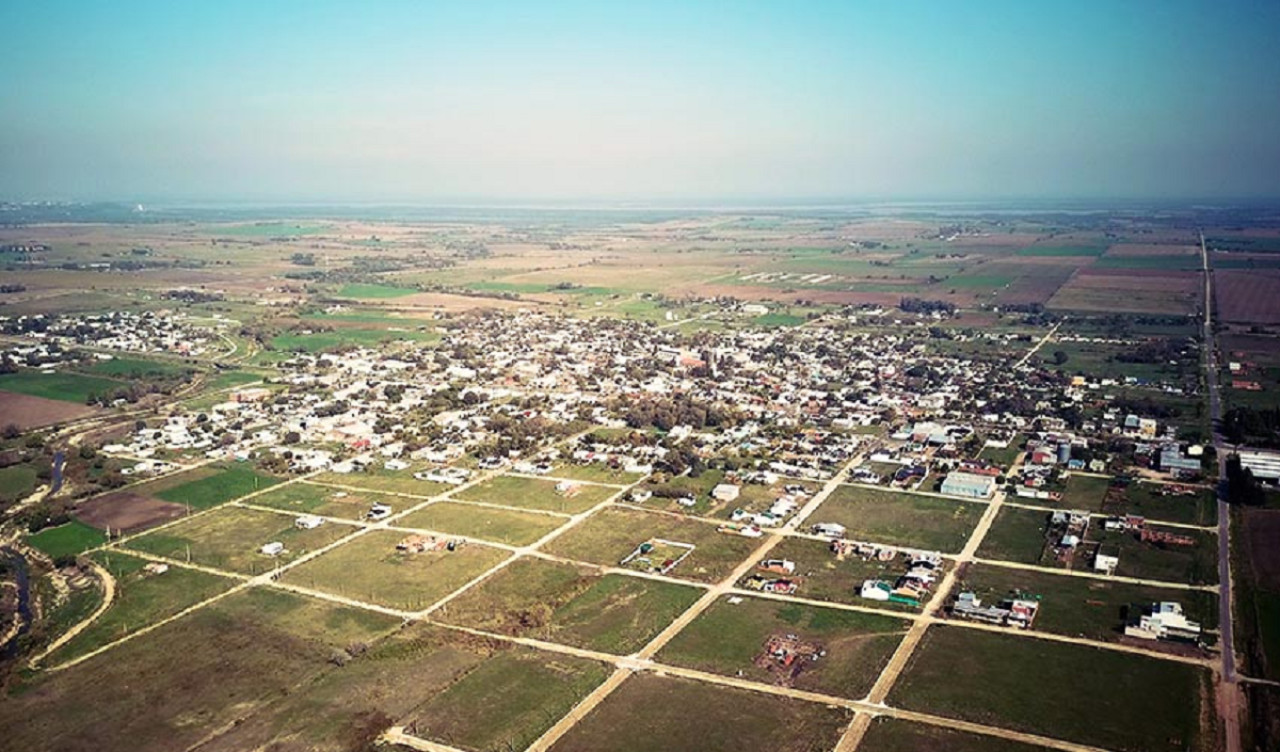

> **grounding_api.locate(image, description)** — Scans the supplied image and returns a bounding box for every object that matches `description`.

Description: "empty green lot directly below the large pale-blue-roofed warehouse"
[810,486,987,554]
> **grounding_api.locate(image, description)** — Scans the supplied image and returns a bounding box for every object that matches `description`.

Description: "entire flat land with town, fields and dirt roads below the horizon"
[0,205,1280,752]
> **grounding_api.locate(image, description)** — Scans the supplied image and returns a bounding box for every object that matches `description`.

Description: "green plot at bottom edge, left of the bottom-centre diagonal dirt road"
[410,648,609,752]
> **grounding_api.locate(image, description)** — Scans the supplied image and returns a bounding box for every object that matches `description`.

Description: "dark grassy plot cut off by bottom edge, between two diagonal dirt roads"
[552,673,850,752]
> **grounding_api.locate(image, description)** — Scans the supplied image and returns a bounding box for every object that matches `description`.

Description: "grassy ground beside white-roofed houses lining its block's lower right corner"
[767,537,919,611]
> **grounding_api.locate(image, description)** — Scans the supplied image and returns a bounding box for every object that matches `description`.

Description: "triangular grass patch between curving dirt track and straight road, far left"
[49,551,236,664]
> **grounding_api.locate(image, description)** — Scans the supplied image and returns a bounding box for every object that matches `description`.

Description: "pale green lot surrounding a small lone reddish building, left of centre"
[283,526,507,610]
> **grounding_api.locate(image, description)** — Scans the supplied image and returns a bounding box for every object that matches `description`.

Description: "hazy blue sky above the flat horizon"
[0,0,1280,205]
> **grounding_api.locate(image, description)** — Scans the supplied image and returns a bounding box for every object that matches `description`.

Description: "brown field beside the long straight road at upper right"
[1048,269,1202,315]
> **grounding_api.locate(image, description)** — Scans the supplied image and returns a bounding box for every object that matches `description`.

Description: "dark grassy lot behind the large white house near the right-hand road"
[956,564,1217,642]
